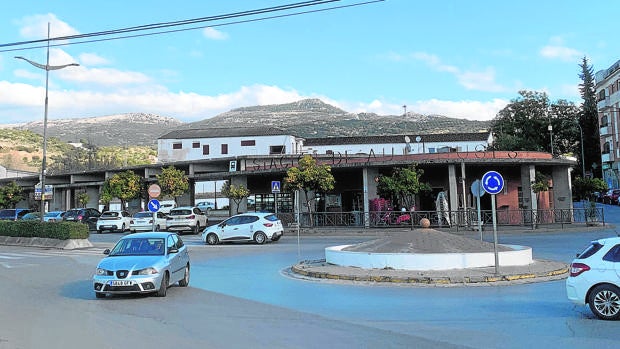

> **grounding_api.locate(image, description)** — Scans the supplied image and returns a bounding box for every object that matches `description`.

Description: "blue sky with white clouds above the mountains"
[0,0,620,124]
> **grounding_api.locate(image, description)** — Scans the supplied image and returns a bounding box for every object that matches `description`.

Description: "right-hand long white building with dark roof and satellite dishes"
[303,132,493,155]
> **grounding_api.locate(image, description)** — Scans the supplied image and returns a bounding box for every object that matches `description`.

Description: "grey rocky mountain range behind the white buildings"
[4,99,490,146]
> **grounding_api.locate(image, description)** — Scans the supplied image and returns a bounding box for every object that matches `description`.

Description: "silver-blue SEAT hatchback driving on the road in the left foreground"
[93,232,190,298]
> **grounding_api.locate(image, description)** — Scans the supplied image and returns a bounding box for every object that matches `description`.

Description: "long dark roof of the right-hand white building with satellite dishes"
[304,132,490,146]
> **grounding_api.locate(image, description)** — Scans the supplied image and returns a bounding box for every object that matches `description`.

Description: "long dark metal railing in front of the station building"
[278,207,605,230]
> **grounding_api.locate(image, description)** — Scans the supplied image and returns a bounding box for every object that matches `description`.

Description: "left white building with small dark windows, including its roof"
[157,127,303,162]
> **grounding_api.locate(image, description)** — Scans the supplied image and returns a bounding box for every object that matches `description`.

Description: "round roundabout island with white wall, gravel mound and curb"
[290,228,568,286]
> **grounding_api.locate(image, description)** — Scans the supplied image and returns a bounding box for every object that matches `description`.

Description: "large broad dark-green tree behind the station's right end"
[489,91,579,155]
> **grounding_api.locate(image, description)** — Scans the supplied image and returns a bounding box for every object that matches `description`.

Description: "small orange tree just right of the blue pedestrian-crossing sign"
[284,155,336,221]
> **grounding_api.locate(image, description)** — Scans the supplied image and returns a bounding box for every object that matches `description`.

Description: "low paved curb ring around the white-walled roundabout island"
[290,260,569,286]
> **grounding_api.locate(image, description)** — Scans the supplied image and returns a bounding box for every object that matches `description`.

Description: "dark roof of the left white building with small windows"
[159,127,289,139]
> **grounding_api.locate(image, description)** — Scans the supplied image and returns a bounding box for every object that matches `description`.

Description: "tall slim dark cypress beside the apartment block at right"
[578,56,602,178]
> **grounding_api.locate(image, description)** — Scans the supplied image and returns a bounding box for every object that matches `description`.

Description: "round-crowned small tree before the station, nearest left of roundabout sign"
[377,164,431,208]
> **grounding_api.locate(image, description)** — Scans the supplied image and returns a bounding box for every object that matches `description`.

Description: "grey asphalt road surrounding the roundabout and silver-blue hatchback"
[0,200,620,349]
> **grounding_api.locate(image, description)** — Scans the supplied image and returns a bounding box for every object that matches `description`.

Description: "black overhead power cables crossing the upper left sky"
[0,0,385,52]
